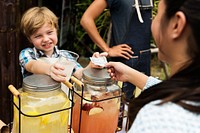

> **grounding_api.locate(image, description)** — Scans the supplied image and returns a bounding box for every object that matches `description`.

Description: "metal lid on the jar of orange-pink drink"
[83,68,112,83]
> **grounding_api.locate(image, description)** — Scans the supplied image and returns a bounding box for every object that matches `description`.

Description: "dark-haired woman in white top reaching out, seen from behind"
[106,0,200,133]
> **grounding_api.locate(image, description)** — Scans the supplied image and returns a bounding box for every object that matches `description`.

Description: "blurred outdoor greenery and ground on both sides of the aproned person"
[65,0,168,79]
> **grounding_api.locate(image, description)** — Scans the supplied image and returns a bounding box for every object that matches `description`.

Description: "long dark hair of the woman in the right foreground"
[128,0,200,127]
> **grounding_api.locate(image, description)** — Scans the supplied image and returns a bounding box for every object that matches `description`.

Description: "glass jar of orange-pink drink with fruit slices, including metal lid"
[72,69,121,133]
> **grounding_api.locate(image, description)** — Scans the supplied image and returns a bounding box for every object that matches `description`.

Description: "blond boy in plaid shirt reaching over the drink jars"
[19,7,103,82]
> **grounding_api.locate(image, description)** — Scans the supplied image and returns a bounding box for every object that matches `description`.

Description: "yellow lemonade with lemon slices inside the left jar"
[12,88,70,133]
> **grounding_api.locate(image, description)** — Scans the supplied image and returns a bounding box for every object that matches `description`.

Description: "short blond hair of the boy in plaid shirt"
[21,7,59,38]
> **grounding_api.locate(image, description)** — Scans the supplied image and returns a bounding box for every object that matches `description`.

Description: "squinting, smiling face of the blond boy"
[29,23,58,57]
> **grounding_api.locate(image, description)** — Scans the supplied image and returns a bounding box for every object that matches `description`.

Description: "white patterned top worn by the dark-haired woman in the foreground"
[128,77,200,133]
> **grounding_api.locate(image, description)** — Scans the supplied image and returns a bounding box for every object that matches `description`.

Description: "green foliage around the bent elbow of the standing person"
[73,0,110,56]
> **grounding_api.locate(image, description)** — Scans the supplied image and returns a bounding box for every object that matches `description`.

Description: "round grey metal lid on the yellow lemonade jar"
[23,74,61,91]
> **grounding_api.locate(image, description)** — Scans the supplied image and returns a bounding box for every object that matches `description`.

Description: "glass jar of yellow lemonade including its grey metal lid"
[12,75,70,133]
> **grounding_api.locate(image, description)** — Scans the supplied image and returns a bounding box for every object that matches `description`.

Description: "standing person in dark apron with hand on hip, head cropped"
[80,0,152,100]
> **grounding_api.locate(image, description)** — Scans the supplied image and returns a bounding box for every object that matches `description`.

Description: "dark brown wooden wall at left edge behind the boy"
[0,0,37,124]
